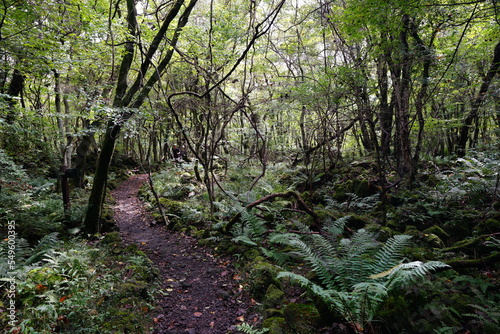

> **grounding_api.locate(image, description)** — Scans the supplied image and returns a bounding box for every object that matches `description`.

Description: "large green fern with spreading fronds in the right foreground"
[271,217,449,333]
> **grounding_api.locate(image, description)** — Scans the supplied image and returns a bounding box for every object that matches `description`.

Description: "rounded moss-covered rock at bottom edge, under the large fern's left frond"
[283,303,320,334]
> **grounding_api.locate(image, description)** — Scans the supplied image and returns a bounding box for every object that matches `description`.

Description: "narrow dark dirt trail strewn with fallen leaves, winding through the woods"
[112,174,252,334]
